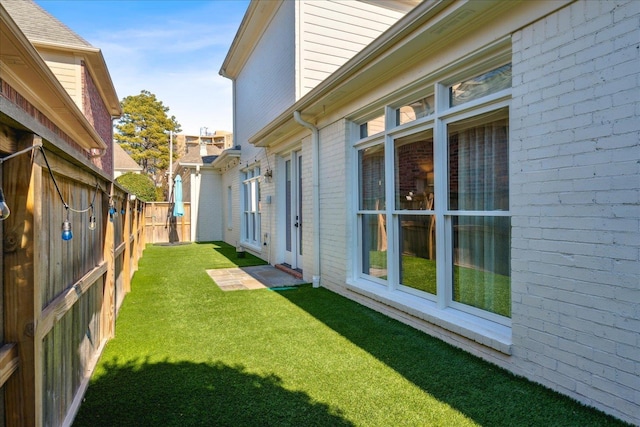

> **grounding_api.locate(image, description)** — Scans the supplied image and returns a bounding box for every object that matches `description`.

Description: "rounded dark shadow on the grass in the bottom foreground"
[73,361,352,427]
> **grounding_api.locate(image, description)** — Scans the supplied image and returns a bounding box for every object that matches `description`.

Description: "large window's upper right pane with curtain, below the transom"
[448,109,509,211]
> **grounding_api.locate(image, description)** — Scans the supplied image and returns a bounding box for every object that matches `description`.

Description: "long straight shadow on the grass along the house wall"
[280,286,628,427]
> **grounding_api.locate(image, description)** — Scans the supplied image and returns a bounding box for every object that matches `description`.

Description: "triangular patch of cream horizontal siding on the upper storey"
[296,0,404,99]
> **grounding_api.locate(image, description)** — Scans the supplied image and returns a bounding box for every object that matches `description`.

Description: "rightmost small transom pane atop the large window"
[449,64,511,107]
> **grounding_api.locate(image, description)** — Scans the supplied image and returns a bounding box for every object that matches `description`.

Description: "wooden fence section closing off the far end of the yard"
[144,202,191,243]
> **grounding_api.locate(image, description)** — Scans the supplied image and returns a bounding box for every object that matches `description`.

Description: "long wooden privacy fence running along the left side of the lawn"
[0,133,145,426]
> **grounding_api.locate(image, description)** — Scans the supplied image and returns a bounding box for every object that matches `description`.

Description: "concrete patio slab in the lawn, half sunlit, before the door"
[207,265,307,291]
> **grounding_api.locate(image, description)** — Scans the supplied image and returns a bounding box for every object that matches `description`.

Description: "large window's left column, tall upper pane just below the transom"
[358,144,385,210]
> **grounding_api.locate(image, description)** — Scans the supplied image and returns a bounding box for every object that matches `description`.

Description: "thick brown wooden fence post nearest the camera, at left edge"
[3,134,42,426]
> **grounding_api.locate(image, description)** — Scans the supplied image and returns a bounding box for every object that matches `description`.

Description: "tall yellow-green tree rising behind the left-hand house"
[114,90,182,186]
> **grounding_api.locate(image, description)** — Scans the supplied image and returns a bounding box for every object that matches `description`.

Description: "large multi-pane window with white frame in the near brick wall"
[354,64,511,324]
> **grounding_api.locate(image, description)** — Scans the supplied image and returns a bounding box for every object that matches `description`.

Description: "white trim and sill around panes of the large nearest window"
[347,58,512,354]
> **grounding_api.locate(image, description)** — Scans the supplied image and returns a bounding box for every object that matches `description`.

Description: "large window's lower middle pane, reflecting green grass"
[399,215,436,295]
